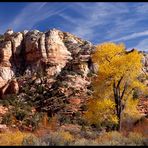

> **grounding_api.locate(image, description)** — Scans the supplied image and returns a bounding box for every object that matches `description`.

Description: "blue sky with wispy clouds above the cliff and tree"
[0,2,148,51]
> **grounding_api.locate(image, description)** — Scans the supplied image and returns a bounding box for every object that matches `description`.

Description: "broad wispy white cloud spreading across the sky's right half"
[60,2,148,41]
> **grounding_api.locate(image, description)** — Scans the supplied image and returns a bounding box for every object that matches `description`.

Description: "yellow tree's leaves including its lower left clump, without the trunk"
[85,42,144,127]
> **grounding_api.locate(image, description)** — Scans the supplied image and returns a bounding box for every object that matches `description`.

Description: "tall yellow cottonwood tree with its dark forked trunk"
[88,42,143,130]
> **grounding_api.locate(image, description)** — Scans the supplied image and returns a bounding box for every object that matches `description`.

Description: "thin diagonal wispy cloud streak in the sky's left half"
[0,2,67,31]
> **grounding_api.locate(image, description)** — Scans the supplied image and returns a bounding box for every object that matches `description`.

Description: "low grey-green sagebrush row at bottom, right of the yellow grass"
[23,130,148,146]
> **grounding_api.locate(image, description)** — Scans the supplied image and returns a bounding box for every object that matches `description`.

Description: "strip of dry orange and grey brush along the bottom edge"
[0,119,148,146]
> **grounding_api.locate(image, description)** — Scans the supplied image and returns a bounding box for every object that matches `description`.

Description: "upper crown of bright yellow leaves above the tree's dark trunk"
[92,42,142,98]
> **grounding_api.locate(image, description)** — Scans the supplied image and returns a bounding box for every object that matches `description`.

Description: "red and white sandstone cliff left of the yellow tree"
[0,29,96,117]
